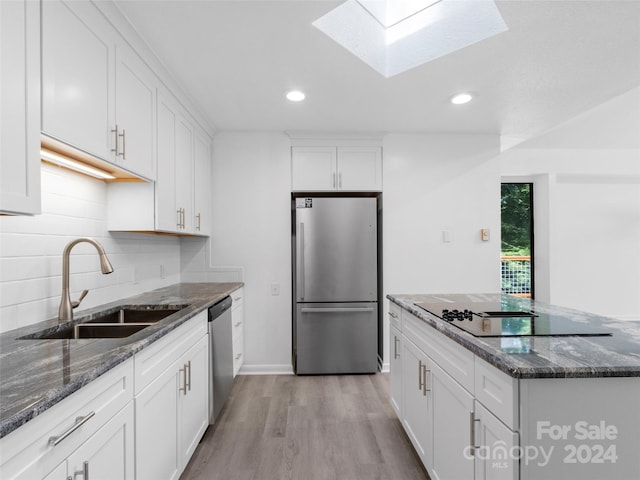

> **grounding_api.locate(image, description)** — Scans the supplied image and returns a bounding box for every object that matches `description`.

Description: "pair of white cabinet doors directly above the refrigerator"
[291,147,382,191]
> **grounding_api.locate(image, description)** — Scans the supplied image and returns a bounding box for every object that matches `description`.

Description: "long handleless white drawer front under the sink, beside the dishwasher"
[134,311,207,395]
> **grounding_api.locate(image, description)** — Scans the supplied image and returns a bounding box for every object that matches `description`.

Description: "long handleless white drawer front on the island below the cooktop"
[402,310,474,393]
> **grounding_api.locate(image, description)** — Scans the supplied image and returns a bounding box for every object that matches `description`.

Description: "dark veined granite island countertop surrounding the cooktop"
[387,294,640,378]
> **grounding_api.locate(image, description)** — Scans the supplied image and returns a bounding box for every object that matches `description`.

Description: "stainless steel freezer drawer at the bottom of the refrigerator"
[296,302,378,374]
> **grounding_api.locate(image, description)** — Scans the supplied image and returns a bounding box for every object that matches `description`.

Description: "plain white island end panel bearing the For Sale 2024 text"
[520,377,640,480]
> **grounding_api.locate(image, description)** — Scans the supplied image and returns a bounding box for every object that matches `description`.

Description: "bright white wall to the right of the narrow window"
[500,87,640,320]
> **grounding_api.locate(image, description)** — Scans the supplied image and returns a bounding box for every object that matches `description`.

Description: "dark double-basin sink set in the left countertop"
[19,305,187,340]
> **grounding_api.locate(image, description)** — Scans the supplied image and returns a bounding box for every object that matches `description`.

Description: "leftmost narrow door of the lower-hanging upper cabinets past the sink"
[155,94,181,232]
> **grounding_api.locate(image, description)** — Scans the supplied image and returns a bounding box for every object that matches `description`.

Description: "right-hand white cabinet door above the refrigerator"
[337,147,382,191]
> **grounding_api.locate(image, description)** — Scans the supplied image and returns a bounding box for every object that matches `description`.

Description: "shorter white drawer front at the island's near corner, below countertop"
[475,358,519,430]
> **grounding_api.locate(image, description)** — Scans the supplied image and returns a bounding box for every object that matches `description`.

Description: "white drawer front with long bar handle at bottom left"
[0,359,133,480]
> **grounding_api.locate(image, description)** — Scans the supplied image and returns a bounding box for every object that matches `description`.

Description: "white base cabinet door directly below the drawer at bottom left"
[67,402,134,480]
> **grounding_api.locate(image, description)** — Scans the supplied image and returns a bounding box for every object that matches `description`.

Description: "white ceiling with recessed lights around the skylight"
[116,0,640,140]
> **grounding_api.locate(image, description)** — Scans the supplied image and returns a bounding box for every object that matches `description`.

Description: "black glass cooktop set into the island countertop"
[415,303,611,337]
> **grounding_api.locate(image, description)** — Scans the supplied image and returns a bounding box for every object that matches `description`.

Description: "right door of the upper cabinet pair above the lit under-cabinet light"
[114,44,156,180]
